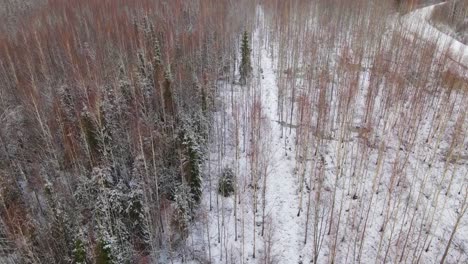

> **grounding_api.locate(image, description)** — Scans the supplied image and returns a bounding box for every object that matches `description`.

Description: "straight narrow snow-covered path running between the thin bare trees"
[253,12,304,263]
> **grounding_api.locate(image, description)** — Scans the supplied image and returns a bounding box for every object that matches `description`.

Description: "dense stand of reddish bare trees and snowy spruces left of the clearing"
[0,0,253,263]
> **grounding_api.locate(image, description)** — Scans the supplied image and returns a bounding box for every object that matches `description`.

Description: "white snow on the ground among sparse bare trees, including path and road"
[176,2,468,263]
